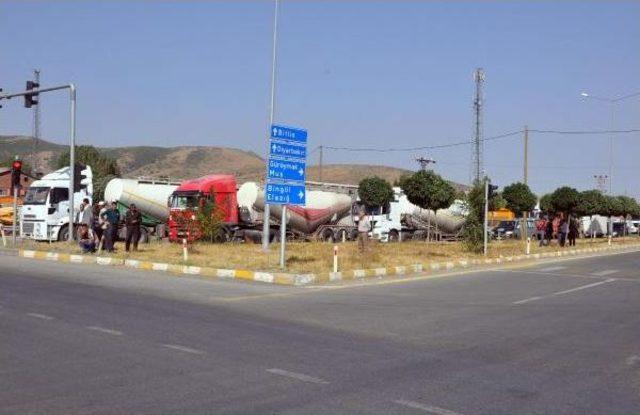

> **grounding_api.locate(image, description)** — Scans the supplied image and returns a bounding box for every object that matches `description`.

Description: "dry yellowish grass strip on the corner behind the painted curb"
[24,237,640,273]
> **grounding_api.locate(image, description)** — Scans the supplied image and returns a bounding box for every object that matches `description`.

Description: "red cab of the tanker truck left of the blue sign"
[169,174,238,242]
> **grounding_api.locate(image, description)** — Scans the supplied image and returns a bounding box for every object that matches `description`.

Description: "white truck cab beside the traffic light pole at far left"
[20,166,93,241]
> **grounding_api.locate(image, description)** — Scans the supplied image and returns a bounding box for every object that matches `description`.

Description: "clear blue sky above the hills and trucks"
[0,0,640,197]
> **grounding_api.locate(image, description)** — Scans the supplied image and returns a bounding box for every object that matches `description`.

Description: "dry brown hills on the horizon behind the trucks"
[0,136,460,188]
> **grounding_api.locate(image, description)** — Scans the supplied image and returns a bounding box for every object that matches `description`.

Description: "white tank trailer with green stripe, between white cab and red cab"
[104,179,180,243]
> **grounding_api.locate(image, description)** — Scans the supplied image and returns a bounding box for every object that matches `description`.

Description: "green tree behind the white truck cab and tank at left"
[56,146,120,200]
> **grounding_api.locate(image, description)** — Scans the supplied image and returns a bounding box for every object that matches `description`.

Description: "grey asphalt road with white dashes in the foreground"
[0,249,640,415]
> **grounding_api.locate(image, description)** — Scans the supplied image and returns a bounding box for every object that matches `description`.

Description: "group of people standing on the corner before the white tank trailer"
[76,199,142,253]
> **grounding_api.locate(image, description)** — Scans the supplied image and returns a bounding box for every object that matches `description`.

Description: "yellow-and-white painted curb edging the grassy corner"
[13,244,640,286]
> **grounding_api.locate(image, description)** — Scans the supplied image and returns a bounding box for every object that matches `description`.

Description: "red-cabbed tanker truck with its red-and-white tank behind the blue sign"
[169,175,357,242]
